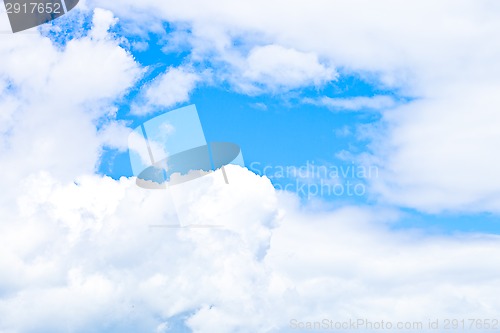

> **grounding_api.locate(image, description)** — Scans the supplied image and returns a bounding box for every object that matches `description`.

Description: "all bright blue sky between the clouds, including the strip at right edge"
[85,14,500,234]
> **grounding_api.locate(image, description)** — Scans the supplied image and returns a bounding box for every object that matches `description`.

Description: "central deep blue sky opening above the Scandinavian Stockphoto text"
[95,14,396,200]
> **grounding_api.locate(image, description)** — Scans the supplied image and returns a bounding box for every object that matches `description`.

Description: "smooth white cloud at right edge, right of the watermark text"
[371,83,500,213]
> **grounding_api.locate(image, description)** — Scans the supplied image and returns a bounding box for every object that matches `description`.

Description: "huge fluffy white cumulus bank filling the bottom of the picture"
[0,166,500,332]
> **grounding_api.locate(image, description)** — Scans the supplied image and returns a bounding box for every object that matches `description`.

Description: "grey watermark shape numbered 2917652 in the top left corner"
[4,0,79,33]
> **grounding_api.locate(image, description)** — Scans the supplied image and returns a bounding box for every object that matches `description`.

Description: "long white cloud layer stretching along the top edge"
[89,0,488,90]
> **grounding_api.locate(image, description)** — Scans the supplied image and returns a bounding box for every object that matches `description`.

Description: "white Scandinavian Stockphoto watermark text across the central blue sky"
[249,161,379,198]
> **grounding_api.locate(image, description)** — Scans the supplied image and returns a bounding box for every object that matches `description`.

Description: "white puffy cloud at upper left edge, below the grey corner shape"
[0,10,141,185]
